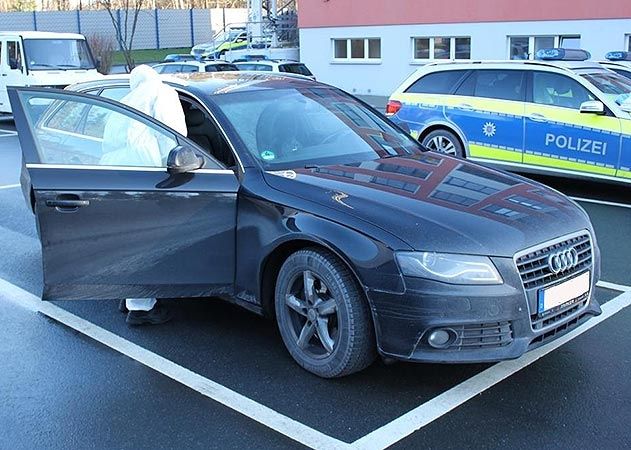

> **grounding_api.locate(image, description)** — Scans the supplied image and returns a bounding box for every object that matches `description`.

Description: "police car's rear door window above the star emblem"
[456,70,526,102]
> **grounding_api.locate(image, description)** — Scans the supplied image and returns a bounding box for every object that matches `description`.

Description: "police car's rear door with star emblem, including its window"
[445,69,527,163]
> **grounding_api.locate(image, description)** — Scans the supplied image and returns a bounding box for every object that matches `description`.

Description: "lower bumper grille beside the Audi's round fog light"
[448,322,513,350]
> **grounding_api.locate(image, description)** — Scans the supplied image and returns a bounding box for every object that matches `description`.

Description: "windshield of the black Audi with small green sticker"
[214,88,421,170]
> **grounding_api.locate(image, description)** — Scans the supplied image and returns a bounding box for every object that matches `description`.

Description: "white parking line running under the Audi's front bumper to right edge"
[352,291,631,450]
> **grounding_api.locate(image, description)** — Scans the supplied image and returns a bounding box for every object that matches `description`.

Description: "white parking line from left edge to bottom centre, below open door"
[0,278,349,449]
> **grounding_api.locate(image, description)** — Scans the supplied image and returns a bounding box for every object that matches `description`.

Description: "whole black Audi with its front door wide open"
[10,72,600,377]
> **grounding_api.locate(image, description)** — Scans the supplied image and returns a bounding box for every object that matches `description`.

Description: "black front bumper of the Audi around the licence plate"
[368,251,601,363]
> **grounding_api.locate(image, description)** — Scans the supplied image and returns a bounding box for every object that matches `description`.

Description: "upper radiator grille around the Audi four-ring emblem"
[516,233,592,289]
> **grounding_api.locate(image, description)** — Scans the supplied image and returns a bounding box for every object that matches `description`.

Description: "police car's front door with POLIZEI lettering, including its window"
[524,71,620,176]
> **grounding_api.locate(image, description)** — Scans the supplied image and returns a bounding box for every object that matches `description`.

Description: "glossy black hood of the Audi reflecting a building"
[265,153,591,257]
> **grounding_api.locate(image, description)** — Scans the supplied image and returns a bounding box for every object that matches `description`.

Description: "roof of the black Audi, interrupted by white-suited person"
[67,71,330,96]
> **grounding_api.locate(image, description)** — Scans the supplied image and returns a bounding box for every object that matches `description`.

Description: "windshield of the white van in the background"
[24,39,95,70]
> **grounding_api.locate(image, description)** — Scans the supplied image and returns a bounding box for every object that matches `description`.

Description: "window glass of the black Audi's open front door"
[21,93,178,167]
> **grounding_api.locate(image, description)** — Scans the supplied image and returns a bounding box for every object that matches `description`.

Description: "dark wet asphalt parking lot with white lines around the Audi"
[0,120,631,449]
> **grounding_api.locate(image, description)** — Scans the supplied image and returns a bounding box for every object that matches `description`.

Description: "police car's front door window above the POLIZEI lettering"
[532,72,594,109]
